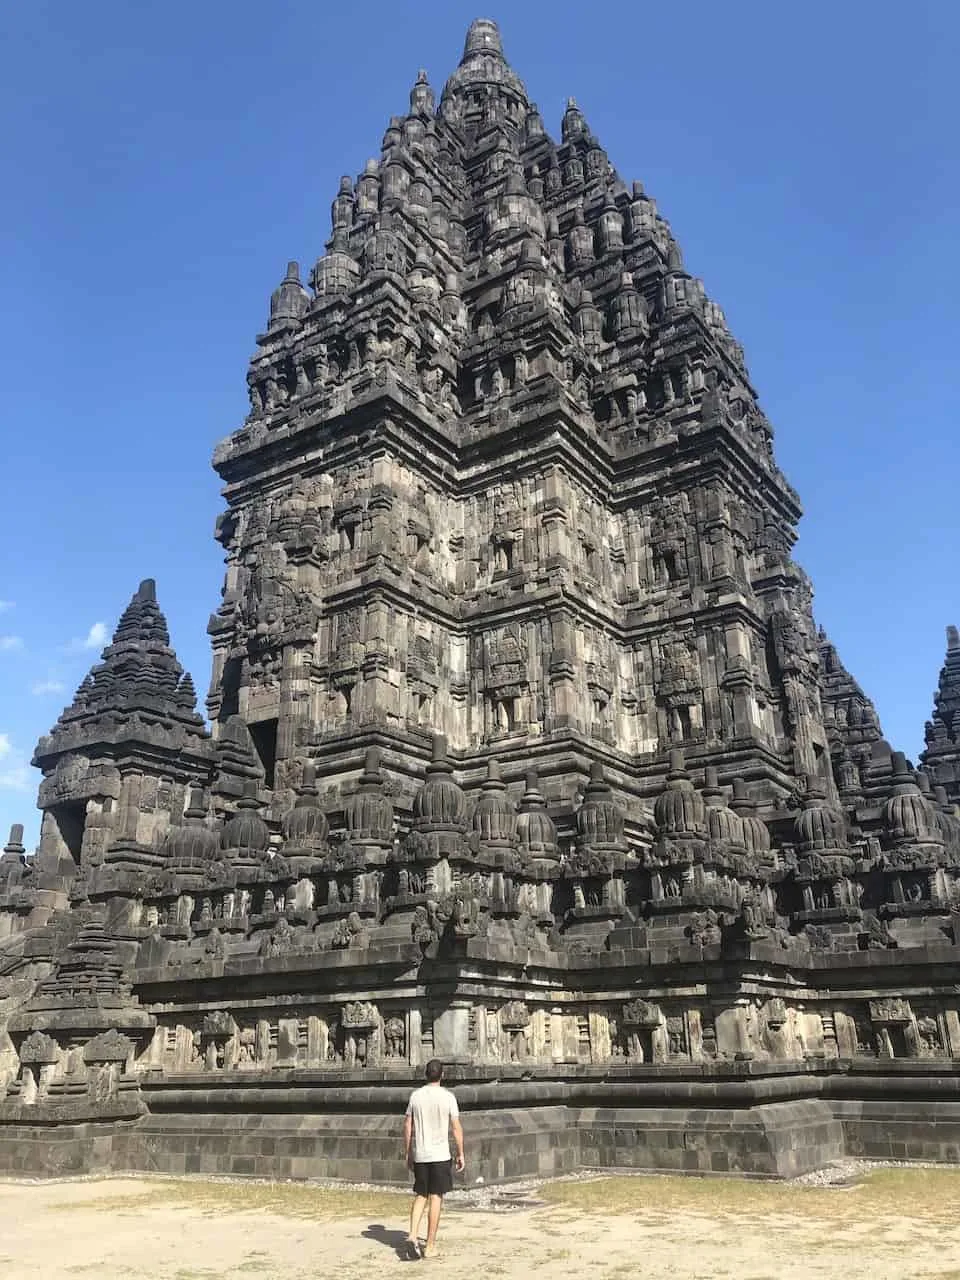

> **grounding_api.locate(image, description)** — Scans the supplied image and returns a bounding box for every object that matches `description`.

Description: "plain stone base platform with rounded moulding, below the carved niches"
[0,1062,960,1185]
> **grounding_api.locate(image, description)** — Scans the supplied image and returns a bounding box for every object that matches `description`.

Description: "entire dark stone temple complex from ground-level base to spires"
[0,20,960,1181]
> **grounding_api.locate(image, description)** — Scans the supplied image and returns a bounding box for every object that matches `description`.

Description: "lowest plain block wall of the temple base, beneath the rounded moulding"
[9,1082,960,1185]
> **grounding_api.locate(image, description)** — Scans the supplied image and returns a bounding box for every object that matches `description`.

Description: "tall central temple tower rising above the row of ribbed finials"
[207,20,833,829]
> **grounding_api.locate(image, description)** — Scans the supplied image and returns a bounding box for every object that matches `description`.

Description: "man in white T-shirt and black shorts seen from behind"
[403,1057,463,1258]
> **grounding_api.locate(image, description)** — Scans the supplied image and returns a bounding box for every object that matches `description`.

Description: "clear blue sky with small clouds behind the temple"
[0,0,960,841]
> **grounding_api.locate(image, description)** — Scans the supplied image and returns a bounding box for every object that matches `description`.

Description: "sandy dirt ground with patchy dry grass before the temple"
[0,1169,960,1280]
